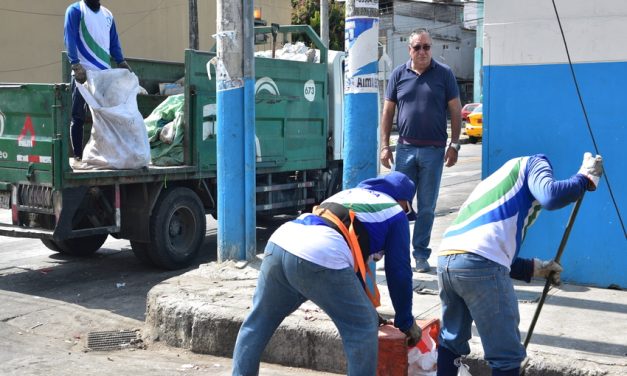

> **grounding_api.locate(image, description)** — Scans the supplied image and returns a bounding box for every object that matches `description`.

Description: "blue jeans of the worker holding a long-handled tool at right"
[438,253,526,371]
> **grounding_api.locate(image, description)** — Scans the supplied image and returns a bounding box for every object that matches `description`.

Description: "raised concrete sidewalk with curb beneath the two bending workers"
[144,201,627,376]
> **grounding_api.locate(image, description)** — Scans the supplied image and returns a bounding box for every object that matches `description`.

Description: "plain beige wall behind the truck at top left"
[0,0,292,82]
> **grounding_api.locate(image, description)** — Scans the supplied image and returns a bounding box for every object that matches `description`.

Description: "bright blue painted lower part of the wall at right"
[482,62,627,288]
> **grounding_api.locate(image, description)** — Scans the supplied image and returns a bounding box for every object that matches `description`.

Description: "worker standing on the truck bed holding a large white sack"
[64,0,131,160]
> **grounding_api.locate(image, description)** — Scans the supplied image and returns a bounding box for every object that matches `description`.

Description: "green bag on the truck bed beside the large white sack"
[144,94,185,166]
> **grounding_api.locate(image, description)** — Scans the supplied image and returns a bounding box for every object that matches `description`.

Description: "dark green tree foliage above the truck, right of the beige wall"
[292,0,344,51]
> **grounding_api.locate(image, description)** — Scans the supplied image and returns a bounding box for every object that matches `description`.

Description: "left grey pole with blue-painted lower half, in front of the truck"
[216,0,256,262]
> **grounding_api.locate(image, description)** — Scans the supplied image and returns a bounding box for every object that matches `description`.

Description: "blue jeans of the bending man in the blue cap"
[233,242,379,376]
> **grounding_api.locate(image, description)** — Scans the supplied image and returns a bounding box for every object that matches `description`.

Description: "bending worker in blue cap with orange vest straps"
[233,172,421,376]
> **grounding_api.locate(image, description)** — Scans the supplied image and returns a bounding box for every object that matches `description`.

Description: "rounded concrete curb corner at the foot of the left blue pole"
[144,259,346,373]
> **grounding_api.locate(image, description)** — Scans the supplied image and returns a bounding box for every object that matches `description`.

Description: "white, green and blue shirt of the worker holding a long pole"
[440,154,588,268]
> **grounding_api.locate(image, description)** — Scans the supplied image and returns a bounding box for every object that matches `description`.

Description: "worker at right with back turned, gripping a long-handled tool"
[437,153,603,376]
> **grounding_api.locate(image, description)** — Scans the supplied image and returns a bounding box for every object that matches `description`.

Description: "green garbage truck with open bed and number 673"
[0,26,343,269]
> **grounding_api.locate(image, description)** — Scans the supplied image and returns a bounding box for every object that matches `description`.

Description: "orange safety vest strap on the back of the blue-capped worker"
[311,206,381,308]
